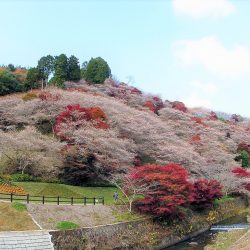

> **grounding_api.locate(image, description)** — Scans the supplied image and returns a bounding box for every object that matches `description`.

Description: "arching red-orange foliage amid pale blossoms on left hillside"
[54,104,109,140]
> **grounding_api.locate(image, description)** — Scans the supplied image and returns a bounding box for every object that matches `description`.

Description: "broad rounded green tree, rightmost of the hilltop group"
[85,57,111,83]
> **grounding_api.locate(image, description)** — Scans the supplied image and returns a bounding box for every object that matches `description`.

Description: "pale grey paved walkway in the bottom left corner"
[0,231,54,250]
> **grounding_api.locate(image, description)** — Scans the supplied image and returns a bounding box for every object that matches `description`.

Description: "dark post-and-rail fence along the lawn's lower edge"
[0,193,104,205]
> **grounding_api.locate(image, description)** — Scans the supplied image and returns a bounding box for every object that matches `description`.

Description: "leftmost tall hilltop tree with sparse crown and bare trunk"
[37,55,55,88]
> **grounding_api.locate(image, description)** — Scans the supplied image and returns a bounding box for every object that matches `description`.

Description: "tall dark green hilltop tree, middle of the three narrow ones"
[51,54,68,87]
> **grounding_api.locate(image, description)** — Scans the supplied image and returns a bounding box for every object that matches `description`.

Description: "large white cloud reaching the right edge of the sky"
[174,36,250,76]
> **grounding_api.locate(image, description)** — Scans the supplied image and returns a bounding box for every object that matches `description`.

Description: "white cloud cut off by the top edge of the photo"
[173,0,236,19]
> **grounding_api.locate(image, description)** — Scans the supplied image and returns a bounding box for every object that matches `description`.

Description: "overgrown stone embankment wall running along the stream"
[50,198,247,250]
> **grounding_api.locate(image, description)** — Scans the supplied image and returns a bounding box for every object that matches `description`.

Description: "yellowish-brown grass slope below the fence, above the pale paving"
[0,203,39,231]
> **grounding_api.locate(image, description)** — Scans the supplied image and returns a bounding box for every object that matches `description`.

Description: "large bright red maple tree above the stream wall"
[131,164,192,217]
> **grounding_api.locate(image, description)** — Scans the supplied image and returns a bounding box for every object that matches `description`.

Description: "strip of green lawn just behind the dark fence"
[15,182,122,205]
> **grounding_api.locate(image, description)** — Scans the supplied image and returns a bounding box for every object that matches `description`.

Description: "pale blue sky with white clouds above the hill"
[0,0,250,117]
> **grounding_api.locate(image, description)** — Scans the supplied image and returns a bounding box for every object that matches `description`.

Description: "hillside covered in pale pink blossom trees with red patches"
[0,81,250,192]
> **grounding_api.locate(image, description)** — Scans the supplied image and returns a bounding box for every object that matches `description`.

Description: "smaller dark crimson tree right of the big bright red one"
[192,179,223,209]
